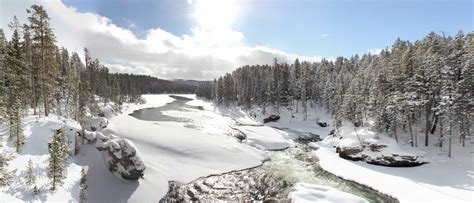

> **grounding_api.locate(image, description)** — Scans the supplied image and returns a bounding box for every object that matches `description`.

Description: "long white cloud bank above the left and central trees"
[0,0,320,79]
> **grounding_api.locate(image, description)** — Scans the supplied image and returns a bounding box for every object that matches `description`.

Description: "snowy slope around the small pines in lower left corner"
[0,114,82,202]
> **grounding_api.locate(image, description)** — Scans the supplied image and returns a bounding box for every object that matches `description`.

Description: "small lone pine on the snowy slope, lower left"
[47,128,68,190]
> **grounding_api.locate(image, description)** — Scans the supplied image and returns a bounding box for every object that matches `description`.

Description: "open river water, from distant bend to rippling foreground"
[130,97,398,202]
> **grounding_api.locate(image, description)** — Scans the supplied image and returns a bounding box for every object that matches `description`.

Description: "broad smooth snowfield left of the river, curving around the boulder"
[86,95,266,202]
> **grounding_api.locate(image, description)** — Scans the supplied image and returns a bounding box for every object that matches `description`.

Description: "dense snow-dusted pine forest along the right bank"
[197,31,474,155]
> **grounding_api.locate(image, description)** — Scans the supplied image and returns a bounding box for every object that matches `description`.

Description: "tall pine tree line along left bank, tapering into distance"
[0,5,195,150]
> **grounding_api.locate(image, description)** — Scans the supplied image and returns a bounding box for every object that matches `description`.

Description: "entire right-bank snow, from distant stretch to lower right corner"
[208,99,474,202]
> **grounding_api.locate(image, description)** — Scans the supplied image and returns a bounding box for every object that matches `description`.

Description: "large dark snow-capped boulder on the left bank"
[96,136,145,180]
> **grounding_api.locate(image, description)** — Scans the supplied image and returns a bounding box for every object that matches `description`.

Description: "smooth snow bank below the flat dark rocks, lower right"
[315,144,474,202]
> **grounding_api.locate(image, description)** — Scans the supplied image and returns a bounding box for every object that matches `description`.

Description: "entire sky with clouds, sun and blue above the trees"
[0,0,474,80]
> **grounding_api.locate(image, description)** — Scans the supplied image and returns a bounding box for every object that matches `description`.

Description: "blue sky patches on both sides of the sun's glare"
[63,0,474,57]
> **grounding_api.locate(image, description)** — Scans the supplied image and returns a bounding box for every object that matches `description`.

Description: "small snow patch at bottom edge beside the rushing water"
[289,183,367,203]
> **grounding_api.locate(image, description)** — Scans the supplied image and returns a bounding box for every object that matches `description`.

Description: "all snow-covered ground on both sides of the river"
[0,95,474,202]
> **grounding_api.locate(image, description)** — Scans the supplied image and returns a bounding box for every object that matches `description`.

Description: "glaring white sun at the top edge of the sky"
[192,0,237,30]
